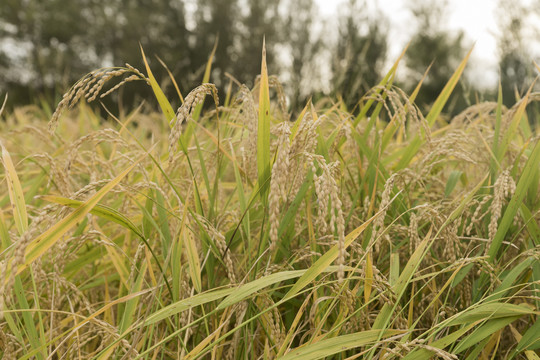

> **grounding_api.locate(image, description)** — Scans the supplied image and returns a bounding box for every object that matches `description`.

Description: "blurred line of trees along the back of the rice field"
[0,0,538,113]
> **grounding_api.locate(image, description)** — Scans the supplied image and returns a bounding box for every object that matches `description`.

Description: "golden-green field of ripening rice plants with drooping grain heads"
[0,46,540,360]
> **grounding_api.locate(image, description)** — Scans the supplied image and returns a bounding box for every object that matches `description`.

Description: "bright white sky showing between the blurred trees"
[316,0,508,88]
